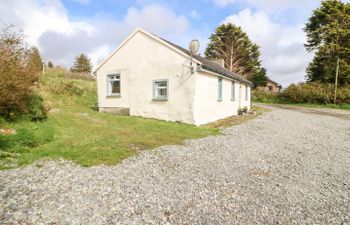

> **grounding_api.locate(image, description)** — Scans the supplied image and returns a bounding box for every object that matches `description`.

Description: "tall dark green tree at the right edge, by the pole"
[304,0,350,85]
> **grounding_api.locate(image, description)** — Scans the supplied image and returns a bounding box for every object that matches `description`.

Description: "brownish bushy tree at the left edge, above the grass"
[0,26,42,119]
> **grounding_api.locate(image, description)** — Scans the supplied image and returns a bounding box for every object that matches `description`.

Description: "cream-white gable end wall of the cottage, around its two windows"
[97,32,195,124]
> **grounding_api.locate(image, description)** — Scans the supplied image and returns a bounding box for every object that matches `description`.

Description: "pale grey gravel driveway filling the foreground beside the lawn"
[0,108,350,224]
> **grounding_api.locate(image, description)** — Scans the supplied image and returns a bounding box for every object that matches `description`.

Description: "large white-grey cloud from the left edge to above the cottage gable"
[0,0,189,66]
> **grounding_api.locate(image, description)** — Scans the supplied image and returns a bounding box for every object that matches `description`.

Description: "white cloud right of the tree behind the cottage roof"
[223,9,312,86]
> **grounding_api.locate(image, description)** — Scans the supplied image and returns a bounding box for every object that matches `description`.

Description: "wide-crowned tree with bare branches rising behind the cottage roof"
[205,23,267,86]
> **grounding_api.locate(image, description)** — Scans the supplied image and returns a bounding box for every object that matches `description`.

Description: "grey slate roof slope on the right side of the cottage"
[160,38,254,86]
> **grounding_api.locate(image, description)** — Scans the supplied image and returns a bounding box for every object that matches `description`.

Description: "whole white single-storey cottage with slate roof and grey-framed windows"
[95,29,253,125]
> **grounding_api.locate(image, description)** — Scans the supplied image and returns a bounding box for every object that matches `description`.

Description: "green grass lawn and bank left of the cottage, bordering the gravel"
[0,73,219,169]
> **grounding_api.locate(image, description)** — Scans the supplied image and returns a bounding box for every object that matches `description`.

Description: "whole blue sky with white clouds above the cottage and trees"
[0,0,340,87]
